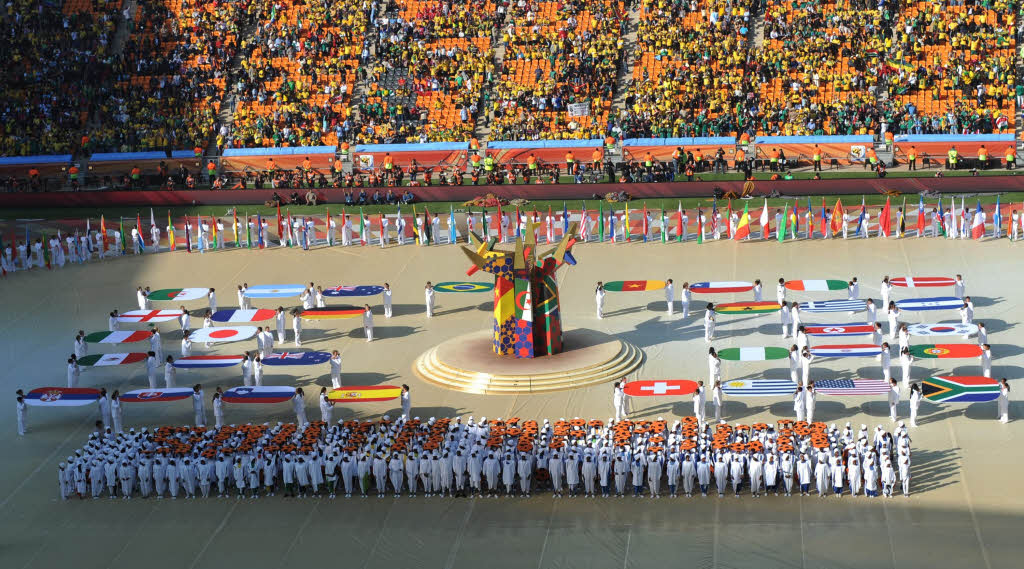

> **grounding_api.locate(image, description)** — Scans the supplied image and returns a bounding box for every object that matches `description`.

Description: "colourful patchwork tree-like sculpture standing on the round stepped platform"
[462,223,579,357]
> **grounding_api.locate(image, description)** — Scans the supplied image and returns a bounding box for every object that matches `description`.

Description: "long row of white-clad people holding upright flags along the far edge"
[0,196,1024,274]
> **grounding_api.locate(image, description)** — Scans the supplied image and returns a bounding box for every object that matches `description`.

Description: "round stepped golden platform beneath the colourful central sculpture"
[413,329,644,395]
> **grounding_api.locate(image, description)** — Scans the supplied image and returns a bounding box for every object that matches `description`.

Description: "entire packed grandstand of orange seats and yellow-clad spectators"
[0,0,1024,189]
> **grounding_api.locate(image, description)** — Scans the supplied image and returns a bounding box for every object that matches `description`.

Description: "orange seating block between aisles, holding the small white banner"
[488,0,626,140]
